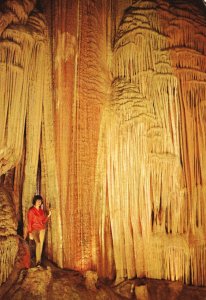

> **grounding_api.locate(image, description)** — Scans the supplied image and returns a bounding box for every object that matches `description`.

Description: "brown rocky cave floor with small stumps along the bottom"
[1,261,206,300]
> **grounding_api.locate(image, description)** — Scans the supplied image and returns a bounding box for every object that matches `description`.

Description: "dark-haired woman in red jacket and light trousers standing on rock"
[28,195,51,267]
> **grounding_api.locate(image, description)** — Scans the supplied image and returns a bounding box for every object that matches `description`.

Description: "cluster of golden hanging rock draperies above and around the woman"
[0,1,62,266]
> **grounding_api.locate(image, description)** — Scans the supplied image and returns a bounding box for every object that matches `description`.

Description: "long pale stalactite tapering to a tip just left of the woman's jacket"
[22,24,45,230]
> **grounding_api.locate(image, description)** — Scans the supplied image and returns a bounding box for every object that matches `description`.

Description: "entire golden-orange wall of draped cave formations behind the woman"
[0,0,206,285]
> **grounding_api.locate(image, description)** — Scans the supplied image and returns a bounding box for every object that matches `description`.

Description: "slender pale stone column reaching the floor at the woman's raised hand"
[40,38,63,267]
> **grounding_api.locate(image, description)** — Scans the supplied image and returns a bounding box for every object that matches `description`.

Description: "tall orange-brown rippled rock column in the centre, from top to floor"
[52,0,109,270]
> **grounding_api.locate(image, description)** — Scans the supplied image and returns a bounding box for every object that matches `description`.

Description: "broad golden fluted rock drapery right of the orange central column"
[96,0,206,285]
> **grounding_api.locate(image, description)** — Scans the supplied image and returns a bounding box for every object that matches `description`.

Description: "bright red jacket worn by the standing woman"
[28,206,48,233]
